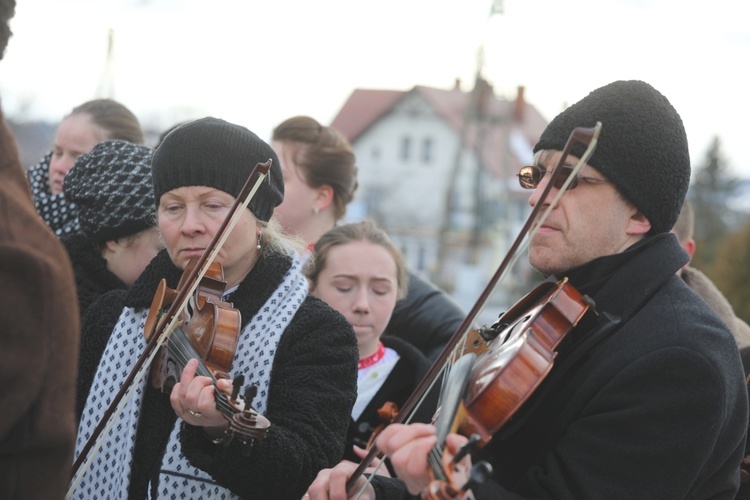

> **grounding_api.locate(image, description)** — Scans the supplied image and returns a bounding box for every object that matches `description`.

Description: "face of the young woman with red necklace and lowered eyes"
[312,241,398,358]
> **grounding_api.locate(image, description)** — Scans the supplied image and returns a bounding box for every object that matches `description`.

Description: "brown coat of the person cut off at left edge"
[0,108,78,499]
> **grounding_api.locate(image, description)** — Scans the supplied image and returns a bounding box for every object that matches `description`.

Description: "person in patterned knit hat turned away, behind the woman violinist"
[61,140,164,316]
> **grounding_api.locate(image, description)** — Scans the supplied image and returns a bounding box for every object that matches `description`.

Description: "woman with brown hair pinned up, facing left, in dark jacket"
[271,116,466,361]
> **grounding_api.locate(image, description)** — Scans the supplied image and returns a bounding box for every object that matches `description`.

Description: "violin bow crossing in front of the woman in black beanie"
[66,158,272,498]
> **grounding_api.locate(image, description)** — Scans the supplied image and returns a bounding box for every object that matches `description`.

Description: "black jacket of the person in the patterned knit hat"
[60,233,127,316]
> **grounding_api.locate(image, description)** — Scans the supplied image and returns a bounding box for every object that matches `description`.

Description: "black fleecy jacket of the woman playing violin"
[78,251,358,499]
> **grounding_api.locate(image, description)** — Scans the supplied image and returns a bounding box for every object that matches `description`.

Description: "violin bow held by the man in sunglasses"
[346,122,602,498]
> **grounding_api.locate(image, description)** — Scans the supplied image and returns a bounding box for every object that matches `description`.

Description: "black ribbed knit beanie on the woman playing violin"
[152,117,284,222]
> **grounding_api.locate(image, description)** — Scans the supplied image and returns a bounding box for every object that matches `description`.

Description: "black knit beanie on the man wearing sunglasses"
[534,80,690,234]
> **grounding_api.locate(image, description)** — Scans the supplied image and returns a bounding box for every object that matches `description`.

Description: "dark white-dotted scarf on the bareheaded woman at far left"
[27,152,80,237]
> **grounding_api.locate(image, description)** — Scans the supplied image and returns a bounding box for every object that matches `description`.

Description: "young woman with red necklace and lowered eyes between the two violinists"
[305,220,439,466]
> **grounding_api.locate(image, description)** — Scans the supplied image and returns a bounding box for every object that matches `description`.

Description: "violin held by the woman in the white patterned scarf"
[144,259,271,455]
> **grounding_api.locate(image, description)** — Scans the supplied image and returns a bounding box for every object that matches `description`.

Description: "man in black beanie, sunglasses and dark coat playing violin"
[308,81,748,499]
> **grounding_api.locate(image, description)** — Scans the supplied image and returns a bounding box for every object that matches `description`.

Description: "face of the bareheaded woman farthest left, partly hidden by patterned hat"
[49,113,106,194]
